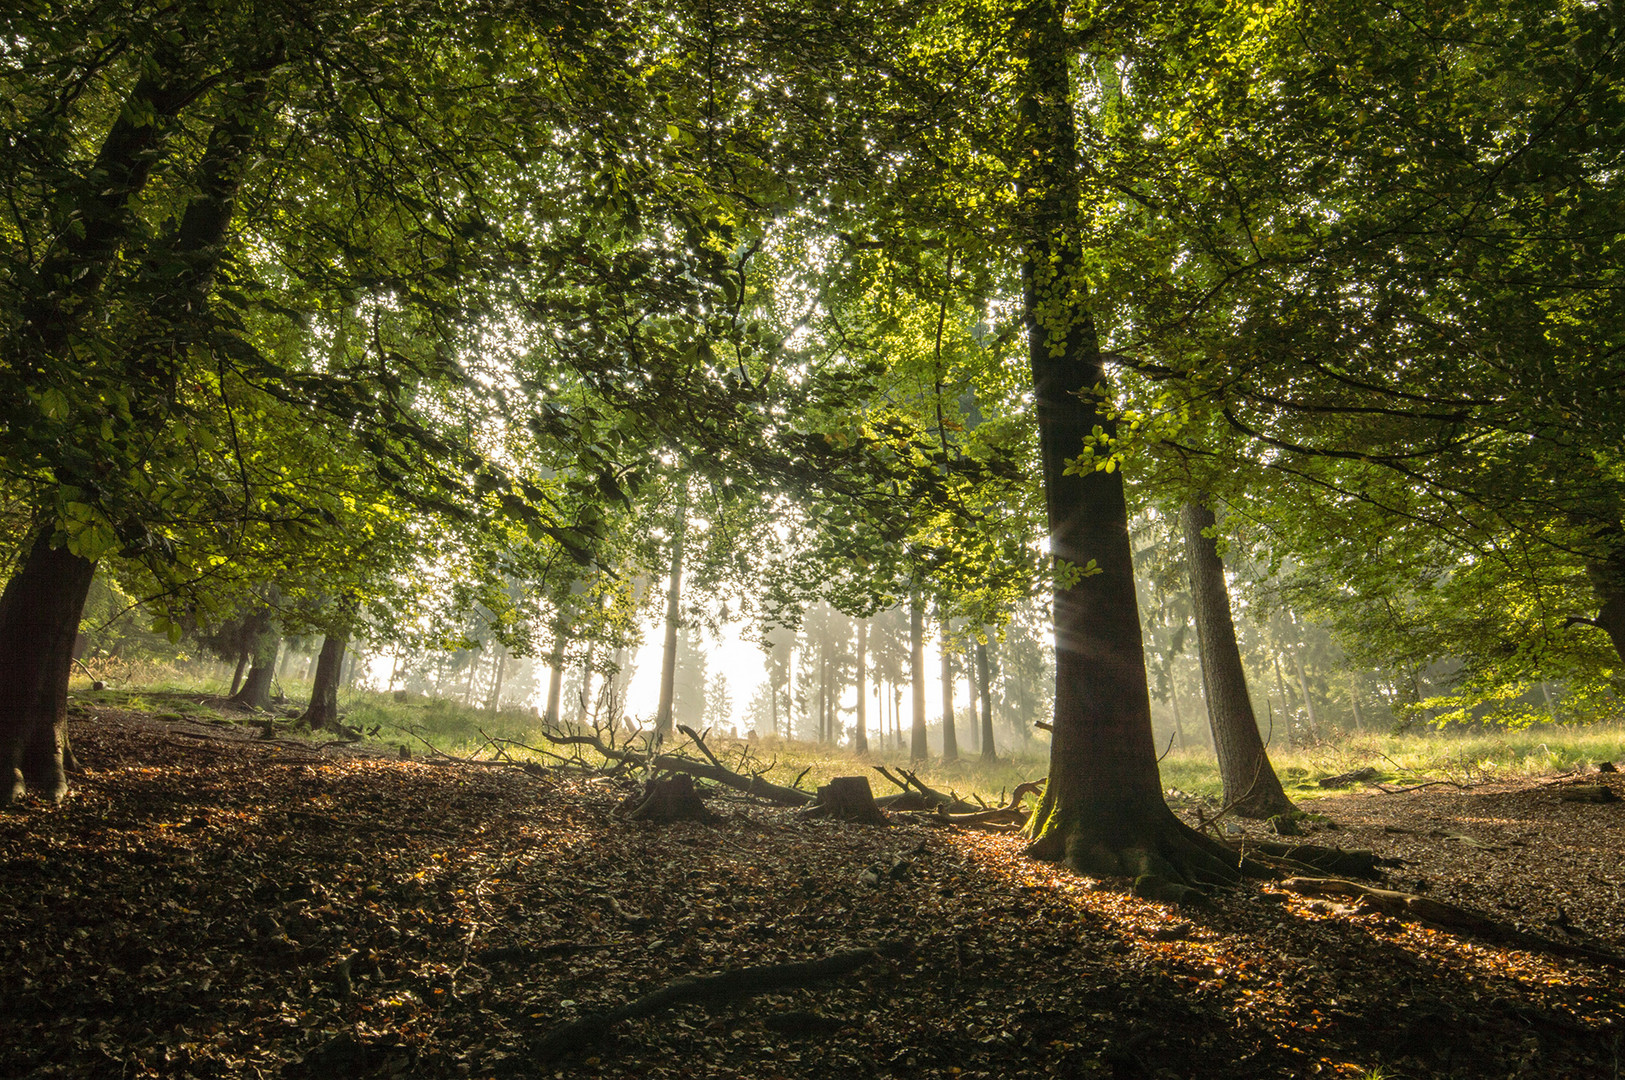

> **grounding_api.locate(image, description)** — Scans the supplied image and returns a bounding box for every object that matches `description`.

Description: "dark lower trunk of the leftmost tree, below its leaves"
[0,525,96,806]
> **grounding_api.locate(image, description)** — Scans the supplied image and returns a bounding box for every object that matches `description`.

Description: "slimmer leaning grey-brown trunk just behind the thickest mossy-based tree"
[1180,502,1292,819]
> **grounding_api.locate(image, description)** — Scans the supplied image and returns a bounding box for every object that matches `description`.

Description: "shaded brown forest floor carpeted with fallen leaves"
[0,708,1625,1080]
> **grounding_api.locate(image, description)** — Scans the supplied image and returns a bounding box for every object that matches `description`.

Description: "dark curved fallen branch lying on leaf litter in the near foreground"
[531,942,912,1062]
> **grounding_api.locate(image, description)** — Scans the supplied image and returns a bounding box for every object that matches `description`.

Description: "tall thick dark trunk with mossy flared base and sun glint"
[1016,0,1235,880]
